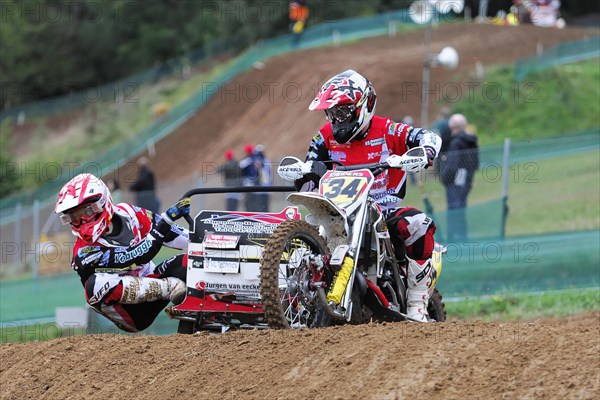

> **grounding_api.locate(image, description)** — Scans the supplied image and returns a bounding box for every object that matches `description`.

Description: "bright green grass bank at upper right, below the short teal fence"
[450,59,600,144]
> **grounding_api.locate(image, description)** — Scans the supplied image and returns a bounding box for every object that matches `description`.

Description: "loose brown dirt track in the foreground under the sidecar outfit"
[0,312,600,400]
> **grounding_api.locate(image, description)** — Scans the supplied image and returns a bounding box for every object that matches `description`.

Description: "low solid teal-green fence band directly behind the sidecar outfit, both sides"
[0,230,600,339]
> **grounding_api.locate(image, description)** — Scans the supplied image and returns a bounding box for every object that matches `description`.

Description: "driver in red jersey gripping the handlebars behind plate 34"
[296,70,442,322]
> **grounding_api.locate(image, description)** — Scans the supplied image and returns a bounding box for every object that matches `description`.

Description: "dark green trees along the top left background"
[0,0,409,109]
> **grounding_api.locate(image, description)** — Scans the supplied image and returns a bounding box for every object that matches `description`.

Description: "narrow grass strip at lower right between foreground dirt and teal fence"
[446,288,600,321]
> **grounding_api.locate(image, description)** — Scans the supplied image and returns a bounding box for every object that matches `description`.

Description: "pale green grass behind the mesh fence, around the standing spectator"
[404,151,600,236]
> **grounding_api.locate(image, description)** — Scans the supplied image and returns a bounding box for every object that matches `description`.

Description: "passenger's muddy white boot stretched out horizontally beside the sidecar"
[120,276,186,304]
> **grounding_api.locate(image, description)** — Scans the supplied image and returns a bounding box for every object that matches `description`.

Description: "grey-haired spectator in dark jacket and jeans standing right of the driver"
[441,114,479,241]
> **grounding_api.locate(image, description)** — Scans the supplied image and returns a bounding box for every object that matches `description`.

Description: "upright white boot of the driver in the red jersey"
[406,257,433,322]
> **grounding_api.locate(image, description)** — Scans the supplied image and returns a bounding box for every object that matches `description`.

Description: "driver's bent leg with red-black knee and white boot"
[387,207,436,322]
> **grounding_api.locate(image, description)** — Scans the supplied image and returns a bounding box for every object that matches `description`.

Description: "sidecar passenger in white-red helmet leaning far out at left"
[55,174,190,332]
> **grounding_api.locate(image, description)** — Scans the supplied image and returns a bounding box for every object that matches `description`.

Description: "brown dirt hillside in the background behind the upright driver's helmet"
[151,23,596,181]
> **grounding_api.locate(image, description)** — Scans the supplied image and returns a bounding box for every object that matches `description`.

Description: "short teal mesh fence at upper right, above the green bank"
[515,36,600,81]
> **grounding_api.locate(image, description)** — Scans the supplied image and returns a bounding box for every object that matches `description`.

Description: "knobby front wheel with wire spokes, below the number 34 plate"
[260,220,334,329]
